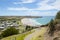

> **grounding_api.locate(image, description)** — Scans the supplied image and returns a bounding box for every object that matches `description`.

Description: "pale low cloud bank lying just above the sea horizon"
[21,10,56,16]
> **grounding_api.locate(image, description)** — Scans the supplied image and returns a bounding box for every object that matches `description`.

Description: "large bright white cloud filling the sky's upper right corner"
[36,0,60,10]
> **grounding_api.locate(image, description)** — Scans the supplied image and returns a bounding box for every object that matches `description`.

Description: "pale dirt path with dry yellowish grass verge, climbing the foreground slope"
[24,27,47,40]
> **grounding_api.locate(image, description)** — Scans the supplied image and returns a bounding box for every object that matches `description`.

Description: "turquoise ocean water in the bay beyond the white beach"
[33,16,55,25]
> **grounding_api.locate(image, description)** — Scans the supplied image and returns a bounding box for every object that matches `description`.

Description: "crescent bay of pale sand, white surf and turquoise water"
[21,16,54,26]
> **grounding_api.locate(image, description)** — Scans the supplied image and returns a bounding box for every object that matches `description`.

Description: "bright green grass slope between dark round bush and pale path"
[2,31,33,40]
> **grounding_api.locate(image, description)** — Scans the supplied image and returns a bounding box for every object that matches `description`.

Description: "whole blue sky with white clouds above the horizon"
[0,0,60,16]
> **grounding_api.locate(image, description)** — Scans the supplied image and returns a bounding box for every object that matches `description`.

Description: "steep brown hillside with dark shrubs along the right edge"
[44,11,60,40]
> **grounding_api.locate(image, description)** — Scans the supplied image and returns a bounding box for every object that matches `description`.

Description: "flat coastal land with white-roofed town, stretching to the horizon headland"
[0,16,41,30]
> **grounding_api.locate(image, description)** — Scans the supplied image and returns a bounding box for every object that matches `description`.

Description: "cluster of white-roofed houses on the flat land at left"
[0,21,19,29]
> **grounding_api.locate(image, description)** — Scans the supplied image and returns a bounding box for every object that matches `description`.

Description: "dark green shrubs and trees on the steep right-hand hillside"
[49,11,60,36]
